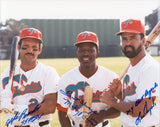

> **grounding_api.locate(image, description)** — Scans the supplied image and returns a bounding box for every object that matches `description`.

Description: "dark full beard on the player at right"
[122,43,142,58]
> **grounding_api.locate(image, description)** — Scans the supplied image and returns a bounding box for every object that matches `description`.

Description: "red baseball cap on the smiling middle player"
[74,31,99,48]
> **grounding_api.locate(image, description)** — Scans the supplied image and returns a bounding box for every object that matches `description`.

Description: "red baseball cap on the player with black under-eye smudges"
[19,28,43,43]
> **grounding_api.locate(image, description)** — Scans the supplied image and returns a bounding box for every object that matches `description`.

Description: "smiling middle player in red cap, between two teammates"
[57,31,119,127]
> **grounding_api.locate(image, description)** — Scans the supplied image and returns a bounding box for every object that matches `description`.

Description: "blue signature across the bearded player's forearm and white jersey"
[126,83,158,125]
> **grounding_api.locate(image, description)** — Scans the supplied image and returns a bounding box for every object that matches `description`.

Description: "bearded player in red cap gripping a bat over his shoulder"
[101,19,160,127]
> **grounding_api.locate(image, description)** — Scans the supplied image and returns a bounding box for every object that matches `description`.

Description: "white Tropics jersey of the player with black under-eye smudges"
[1,62,59,125]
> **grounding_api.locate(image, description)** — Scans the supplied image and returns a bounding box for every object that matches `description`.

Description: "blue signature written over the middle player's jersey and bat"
[60,90,98,126]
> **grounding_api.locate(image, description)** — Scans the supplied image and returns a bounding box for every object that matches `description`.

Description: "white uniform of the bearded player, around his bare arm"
[120,54,160,127]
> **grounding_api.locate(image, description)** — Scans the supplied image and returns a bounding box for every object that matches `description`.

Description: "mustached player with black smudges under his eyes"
[1,28,59,127]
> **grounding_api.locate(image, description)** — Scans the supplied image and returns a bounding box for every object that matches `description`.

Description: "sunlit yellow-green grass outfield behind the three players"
[0,57,160,127]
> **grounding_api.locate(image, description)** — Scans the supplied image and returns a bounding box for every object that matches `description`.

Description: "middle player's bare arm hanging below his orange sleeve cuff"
[58,110,71,127]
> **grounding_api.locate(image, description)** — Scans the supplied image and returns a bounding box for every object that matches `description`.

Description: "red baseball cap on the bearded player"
[116,19,145,35]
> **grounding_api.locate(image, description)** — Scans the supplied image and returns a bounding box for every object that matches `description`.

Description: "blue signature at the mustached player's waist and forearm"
[6,105,43,126]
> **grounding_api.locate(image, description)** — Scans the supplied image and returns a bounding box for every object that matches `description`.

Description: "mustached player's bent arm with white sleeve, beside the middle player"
[28,67,59,115]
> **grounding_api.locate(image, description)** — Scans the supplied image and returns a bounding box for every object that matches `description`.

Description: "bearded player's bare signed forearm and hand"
[101,91,156,117]
